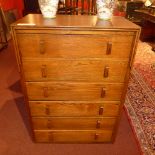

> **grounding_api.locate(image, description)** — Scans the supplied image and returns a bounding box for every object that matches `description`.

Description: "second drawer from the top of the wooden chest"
[23,59,128,82]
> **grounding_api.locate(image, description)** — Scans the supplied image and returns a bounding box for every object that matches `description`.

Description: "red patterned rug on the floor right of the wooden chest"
[125,42,155,155]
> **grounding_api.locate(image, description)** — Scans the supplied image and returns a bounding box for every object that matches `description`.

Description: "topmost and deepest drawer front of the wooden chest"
[17,33,133,58]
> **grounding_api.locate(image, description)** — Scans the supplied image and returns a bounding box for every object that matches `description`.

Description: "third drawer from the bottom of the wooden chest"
[29,101,120,117]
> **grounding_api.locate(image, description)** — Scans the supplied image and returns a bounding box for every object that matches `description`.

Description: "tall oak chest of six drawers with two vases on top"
[12,14,140,143]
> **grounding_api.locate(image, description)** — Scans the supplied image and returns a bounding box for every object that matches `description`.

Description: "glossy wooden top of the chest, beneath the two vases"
[12,14,140,30]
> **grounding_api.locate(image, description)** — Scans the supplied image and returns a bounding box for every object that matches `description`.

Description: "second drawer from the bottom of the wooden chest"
[32,117,116,130]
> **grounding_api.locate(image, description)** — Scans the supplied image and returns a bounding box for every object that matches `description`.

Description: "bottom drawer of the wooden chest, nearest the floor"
[35,130,112,143]
